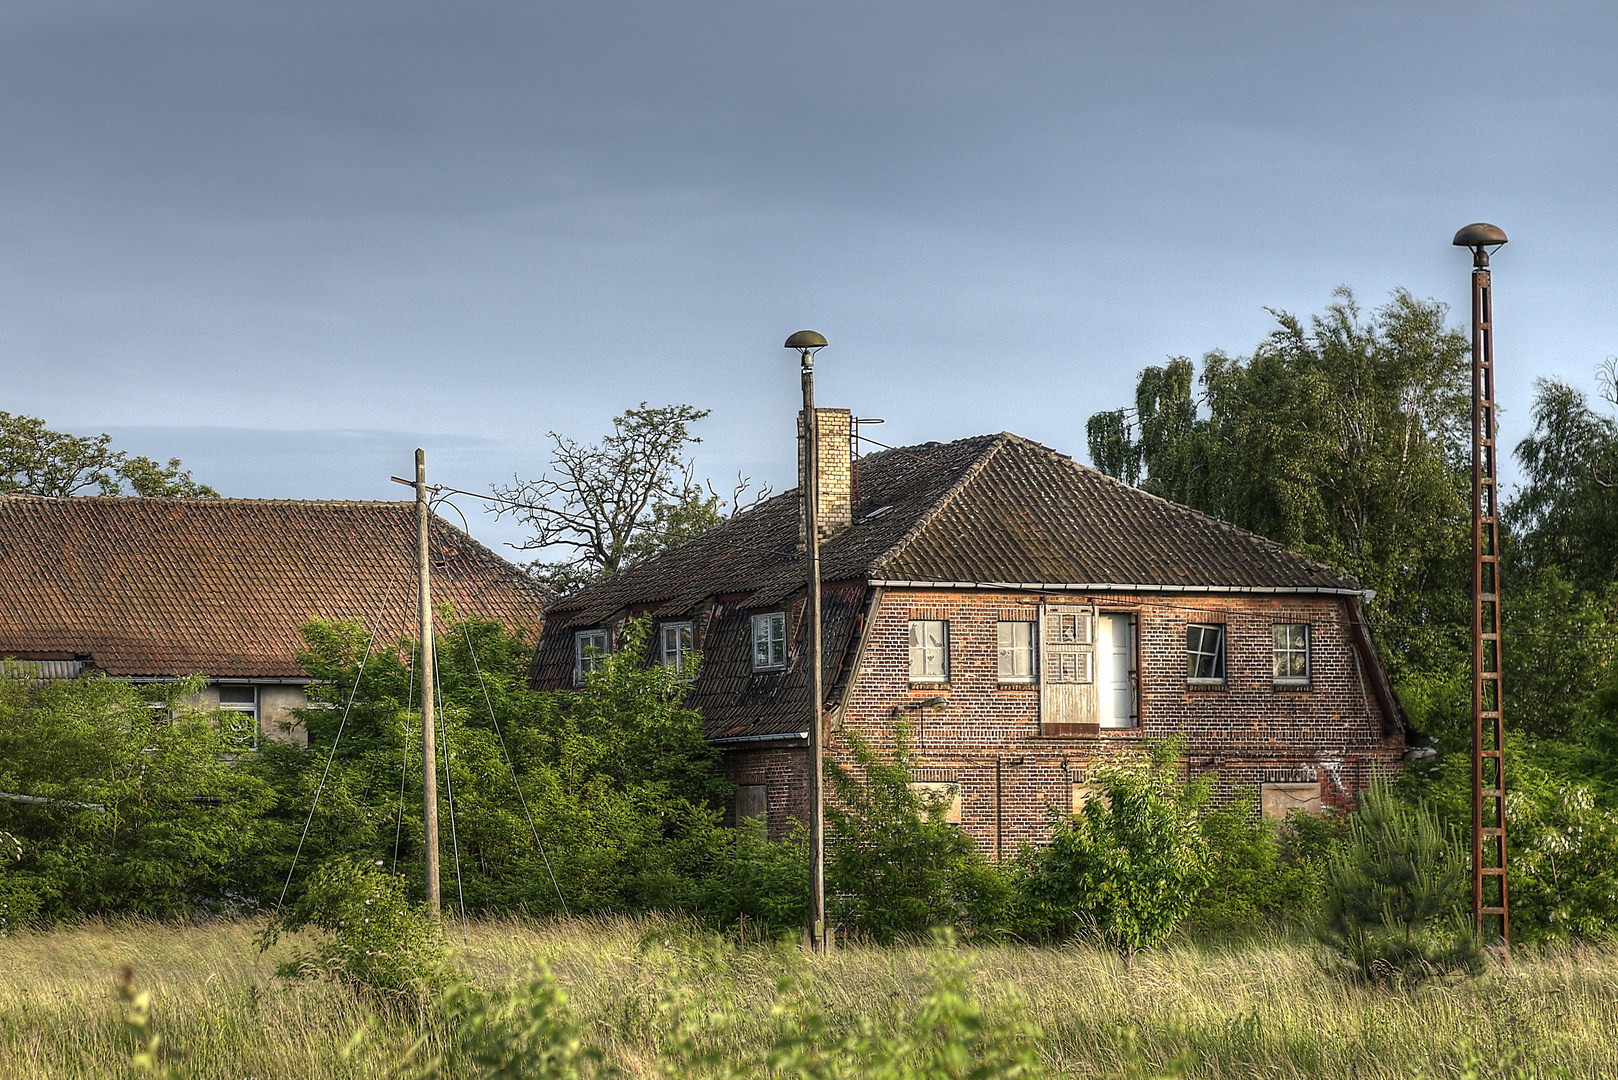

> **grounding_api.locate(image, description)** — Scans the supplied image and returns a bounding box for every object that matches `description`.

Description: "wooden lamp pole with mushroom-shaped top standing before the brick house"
[786,330,827,952]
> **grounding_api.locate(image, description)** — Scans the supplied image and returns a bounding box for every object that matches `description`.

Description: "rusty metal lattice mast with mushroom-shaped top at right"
[1455,222,1511,946]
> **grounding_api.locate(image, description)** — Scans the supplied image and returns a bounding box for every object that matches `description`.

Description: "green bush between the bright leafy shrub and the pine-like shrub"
[1188,789,1332,931]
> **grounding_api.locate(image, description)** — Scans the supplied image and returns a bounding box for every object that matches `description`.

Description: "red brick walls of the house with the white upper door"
[722,589,1404,858]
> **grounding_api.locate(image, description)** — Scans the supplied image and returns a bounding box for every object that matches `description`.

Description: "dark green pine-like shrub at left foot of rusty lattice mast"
[1319,784,1482,983]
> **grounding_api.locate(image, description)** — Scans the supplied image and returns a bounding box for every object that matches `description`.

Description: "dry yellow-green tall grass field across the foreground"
[0,918,1618,1080]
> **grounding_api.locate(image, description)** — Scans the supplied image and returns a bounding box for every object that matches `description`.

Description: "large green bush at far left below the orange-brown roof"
[0,665,273,920]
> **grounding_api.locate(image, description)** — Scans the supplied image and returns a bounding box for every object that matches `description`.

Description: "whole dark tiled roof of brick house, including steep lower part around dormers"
[531,434,1359,738]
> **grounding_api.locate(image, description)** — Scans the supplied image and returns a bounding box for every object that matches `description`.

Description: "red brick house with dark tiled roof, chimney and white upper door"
[531,410,1404,858]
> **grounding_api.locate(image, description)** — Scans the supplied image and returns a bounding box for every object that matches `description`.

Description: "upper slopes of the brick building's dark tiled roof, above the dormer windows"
[550,432,1359,625]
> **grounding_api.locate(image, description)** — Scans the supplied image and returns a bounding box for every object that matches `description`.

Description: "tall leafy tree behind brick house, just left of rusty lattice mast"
[1089,288,1471,667]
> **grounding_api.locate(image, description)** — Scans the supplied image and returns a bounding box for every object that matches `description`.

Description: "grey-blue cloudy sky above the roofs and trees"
[0,0,1618,557]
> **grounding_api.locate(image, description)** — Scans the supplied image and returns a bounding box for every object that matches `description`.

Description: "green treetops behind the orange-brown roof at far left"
[0,413,218,499]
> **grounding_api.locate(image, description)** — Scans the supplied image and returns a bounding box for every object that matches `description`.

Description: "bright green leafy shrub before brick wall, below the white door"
[1019,743,1214,955]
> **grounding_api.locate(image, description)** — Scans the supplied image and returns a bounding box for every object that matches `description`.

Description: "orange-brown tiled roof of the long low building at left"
[0,495,545,678]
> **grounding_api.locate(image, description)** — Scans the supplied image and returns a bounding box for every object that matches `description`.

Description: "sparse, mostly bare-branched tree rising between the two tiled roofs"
[493,402,769,593]
